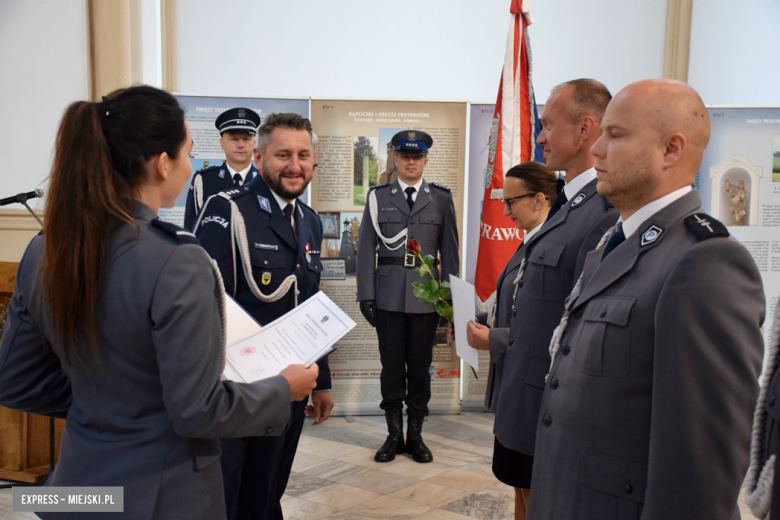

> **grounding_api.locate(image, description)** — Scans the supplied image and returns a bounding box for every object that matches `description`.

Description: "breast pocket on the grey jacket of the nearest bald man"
[572,296,636,377]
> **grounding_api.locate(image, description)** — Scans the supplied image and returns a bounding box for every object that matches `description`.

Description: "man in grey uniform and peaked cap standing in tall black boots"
[357,130,460,462]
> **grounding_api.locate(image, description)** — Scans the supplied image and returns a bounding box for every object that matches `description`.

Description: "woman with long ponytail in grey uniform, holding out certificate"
[0,86,317,520]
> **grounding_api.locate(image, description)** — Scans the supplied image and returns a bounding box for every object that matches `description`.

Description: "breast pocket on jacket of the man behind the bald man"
[523,241,567,301]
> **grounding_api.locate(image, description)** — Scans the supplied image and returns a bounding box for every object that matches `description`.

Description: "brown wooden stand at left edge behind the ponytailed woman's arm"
[0,262,65,484]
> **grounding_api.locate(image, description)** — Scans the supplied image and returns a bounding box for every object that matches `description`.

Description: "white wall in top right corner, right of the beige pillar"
[688,0,780,105]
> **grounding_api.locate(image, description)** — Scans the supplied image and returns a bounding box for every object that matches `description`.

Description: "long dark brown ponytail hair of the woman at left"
[41,86,187,365]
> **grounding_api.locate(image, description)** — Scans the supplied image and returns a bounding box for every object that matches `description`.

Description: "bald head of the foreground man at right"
[591,79,710,218]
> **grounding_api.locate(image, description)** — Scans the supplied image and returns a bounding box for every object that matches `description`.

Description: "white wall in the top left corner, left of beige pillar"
[0,0,89,209]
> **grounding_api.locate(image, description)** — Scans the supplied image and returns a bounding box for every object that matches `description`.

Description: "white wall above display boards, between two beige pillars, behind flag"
[177,0,666,101]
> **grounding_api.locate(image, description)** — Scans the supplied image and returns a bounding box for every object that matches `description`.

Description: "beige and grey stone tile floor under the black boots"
[0,413,756,520]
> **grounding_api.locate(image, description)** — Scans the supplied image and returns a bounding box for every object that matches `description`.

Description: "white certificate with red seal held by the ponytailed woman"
[225,291,355,383]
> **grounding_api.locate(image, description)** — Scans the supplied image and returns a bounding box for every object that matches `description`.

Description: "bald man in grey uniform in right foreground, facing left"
[528,80,765,520]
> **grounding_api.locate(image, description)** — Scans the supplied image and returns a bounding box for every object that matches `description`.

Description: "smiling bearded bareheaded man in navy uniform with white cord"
[195,114,333,520]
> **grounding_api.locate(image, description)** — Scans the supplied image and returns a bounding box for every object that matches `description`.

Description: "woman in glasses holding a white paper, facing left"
[466,162,559,520]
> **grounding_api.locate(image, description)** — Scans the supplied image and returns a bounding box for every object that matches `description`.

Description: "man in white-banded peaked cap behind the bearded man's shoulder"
[184,108,260,230]
